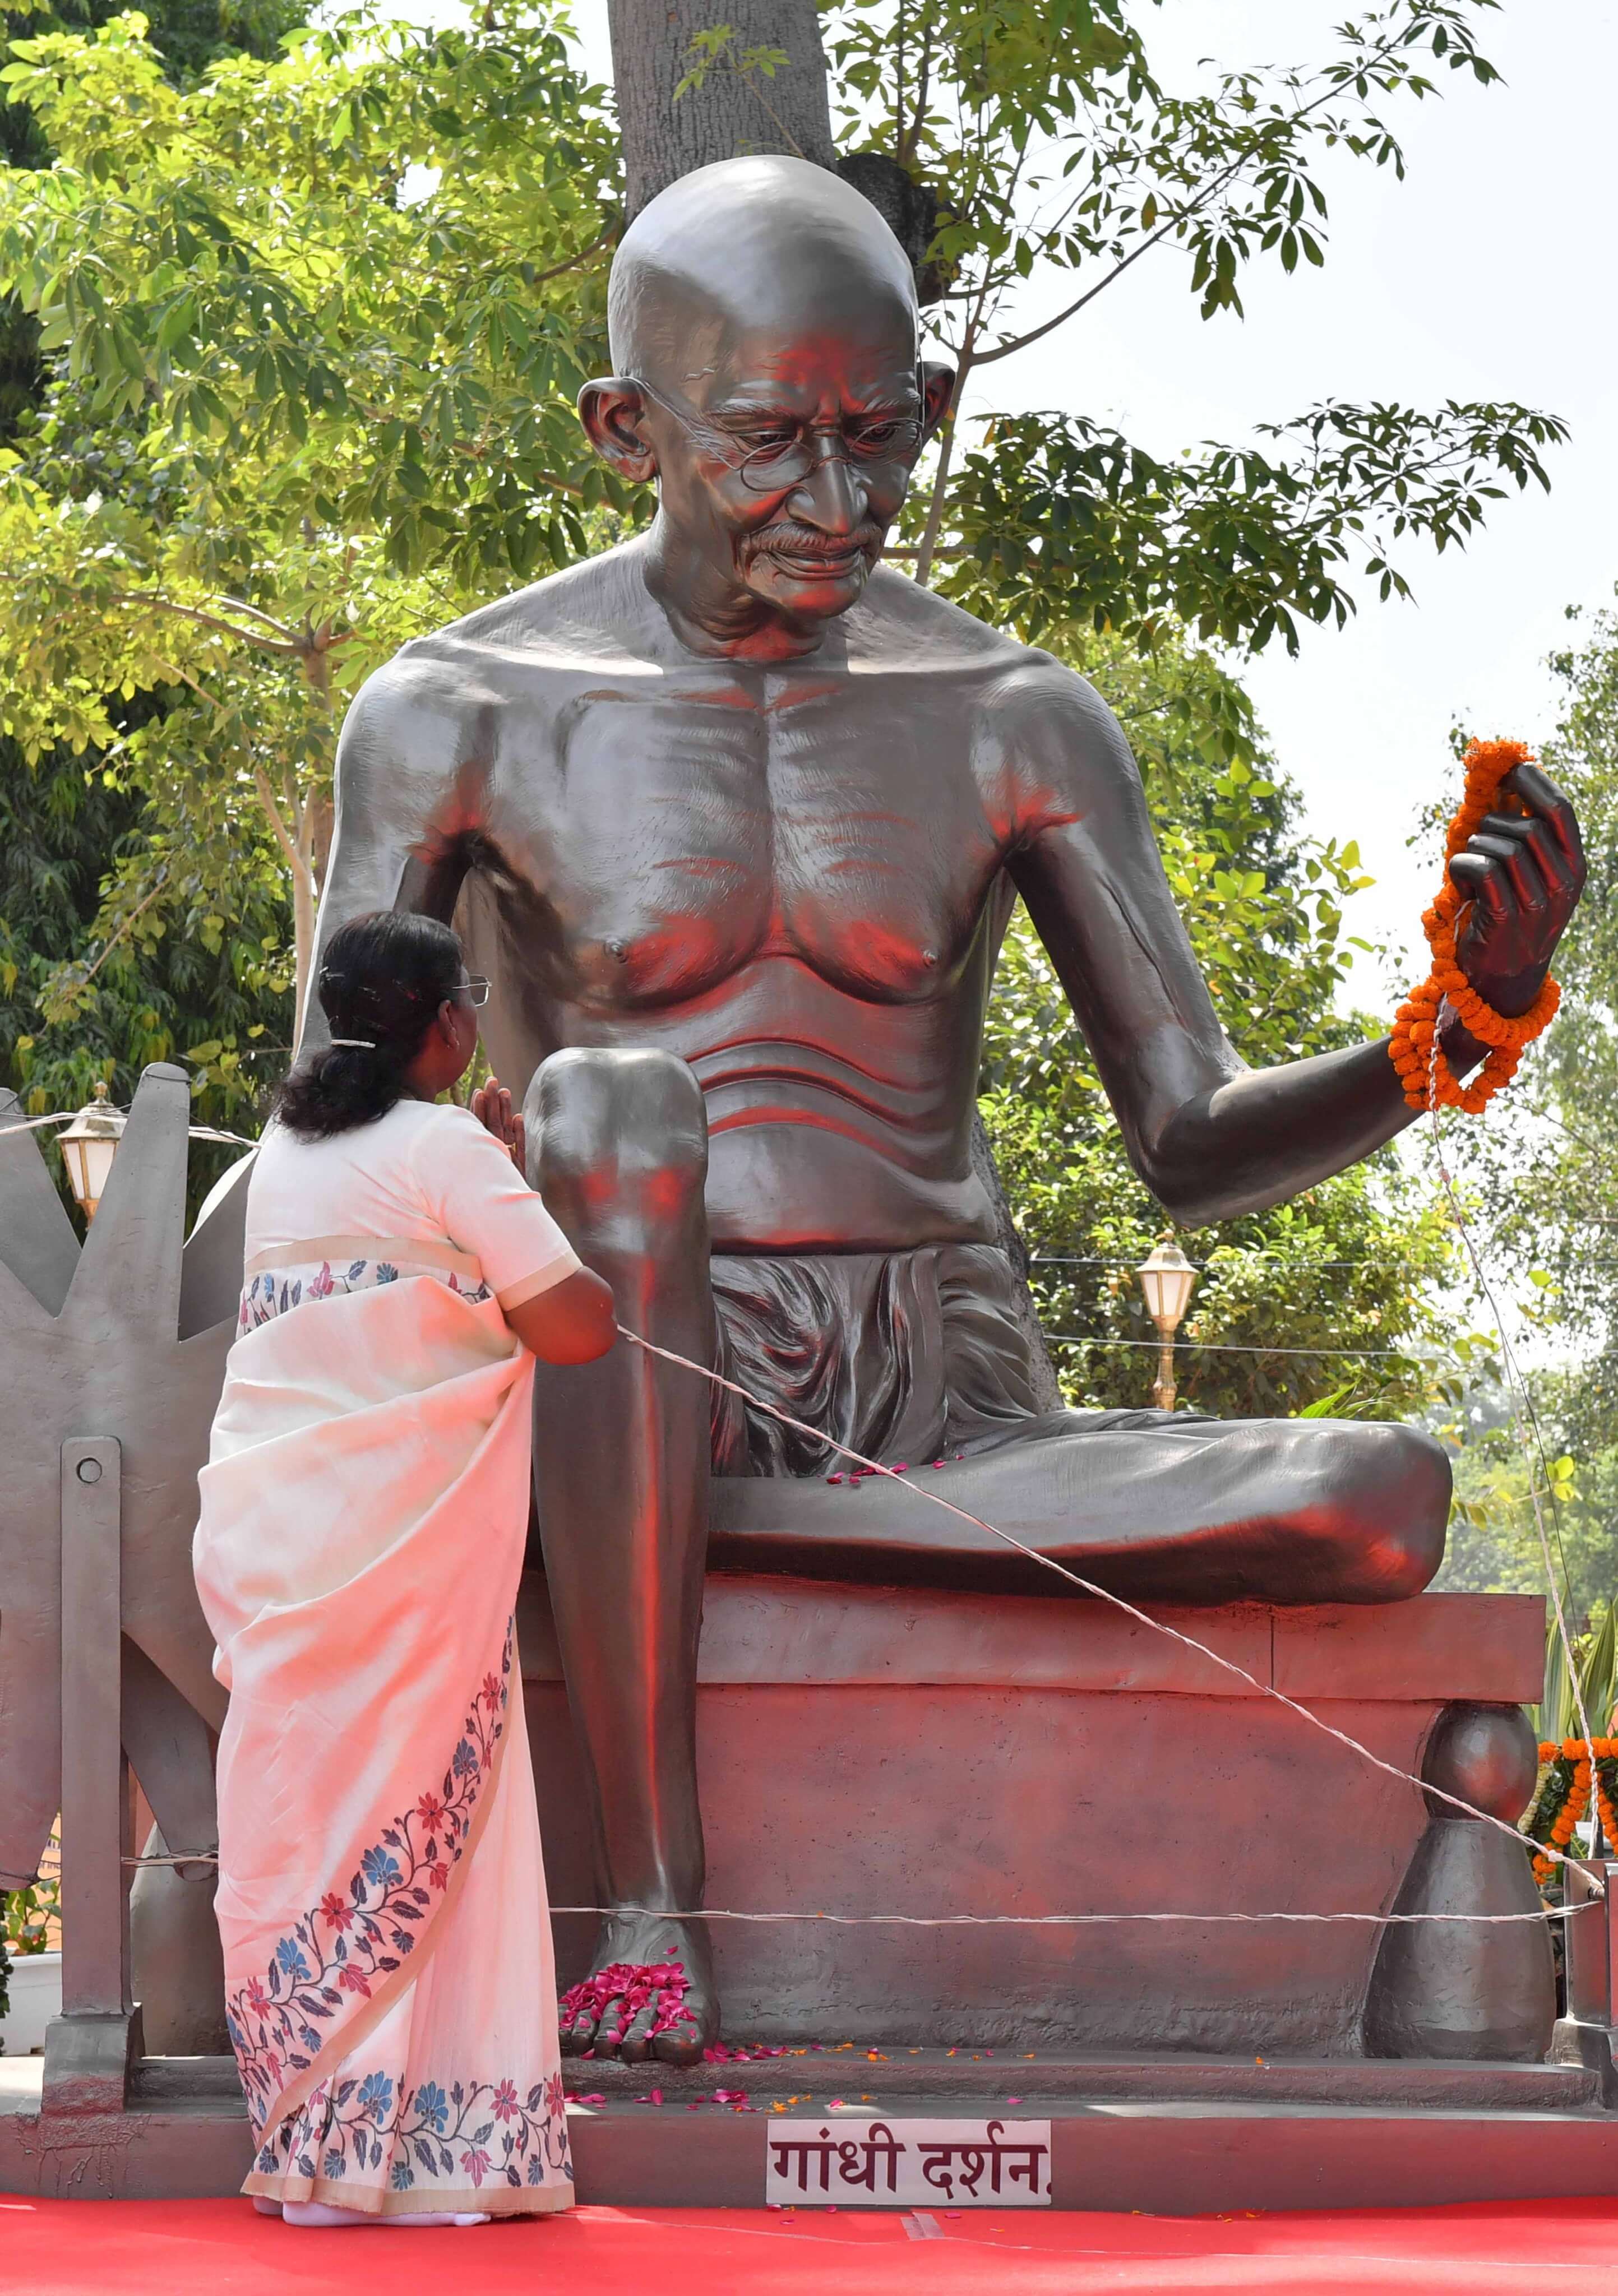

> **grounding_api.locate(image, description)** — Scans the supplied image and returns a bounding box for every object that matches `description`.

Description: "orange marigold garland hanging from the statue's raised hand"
[1389,742,1563,1116]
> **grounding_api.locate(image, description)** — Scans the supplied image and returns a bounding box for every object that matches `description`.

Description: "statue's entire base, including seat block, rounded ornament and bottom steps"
[0,1577,1618,2214]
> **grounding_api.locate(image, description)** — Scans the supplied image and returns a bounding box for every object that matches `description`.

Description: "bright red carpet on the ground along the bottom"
[0,2197,1618,2296]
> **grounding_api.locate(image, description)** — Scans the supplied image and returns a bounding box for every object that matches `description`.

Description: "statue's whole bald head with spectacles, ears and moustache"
[579,159,953,661]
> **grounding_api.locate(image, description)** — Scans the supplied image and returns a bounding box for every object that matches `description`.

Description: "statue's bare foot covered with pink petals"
[560,1913,718,2064]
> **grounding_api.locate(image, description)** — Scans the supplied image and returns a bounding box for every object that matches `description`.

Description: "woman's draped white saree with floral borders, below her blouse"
[195,1242,571,2216]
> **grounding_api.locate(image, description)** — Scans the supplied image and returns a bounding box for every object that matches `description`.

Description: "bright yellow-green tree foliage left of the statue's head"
[0,7,624,1015]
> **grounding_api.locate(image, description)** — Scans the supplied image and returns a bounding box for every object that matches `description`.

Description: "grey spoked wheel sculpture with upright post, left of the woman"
[0,1066,241,2082]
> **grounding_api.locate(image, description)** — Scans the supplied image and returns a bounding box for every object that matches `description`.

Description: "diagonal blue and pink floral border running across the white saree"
[225,1626,514,2131]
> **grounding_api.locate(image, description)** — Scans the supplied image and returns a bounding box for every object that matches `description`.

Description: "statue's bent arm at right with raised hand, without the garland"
[989,656,1584,1224]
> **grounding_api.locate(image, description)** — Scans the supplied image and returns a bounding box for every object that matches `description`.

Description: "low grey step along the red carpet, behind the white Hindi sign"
[0,2057,1618,2216]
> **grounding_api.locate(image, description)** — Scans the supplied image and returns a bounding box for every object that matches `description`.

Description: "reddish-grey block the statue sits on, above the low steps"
[519,1577,1549,2059]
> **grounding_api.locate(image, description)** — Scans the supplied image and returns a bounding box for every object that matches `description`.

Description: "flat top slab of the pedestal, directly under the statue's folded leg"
[516,1571,1545,1706]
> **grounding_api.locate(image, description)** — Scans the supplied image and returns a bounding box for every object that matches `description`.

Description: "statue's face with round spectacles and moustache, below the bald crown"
[581,276,950,631]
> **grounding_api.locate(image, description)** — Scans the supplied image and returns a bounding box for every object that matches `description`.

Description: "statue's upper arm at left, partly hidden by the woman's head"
[303,654,480,1047]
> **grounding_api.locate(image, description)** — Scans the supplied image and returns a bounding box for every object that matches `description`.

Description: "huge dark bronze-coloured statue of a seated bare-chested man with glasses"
[309,159,1582,2062]
